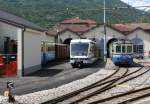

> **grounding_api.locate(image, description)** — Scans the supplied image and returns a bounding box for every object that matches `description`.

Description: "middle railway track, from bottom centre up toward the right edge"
[70,67,147,104]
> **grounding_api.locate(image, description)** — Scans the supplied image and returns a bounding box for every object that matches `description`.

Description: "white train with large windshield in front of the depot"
[70,39,99,68]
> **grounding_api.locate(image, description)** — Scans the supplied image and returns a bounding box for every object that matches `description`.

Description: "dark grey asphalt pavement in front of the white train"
[0,60,105,95]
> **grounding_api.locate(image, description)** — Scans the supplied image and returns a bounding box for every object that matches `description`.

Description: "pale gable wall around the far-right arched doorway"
[127,29,150,57]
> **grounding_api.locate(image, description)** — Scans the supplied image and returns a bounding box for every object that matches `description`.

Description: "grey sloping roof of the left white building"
[0,10,46,31]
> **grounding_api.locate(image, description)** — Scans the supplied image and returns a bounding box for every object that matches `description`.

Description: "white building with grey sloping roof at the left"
[0,11,55,76]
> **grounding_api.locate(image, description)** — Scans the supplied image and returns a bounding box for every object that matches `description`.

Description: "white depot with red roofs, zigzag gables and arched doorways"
[55,18,150,58]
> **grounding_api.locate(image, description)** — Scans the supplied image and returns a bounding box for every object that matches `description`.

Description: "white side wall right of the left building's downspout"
[24,30,41,74]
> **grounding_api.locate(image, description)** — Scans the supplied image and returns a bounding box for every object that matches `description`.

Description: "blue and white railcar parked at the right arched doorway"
[111,39,133,66]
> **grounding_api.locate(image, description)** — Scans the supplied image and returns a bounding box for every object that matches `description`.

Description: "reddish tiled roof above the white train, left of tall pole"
[50,18,96,35]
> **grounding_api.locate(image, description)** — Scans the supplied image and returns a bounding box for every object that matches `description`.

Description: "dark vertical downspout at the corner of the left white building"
[21,27,26,76]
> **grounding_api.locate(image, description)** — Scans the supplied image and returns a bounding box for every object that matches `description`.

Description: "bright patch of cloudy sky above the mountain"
[121,0,150,11]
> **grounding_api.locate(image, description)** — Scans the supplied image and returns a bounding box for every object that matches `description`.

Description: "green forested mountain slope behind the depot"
[0,0,150,27]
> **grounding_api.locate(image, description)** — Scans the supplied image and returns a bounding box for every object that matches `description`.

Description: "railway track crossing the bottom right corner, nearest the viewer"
[90,86,150,104]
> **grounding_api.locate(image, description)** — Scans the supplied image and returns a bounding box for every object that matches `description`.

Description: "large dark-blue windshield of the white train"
[71,43,89,56]
